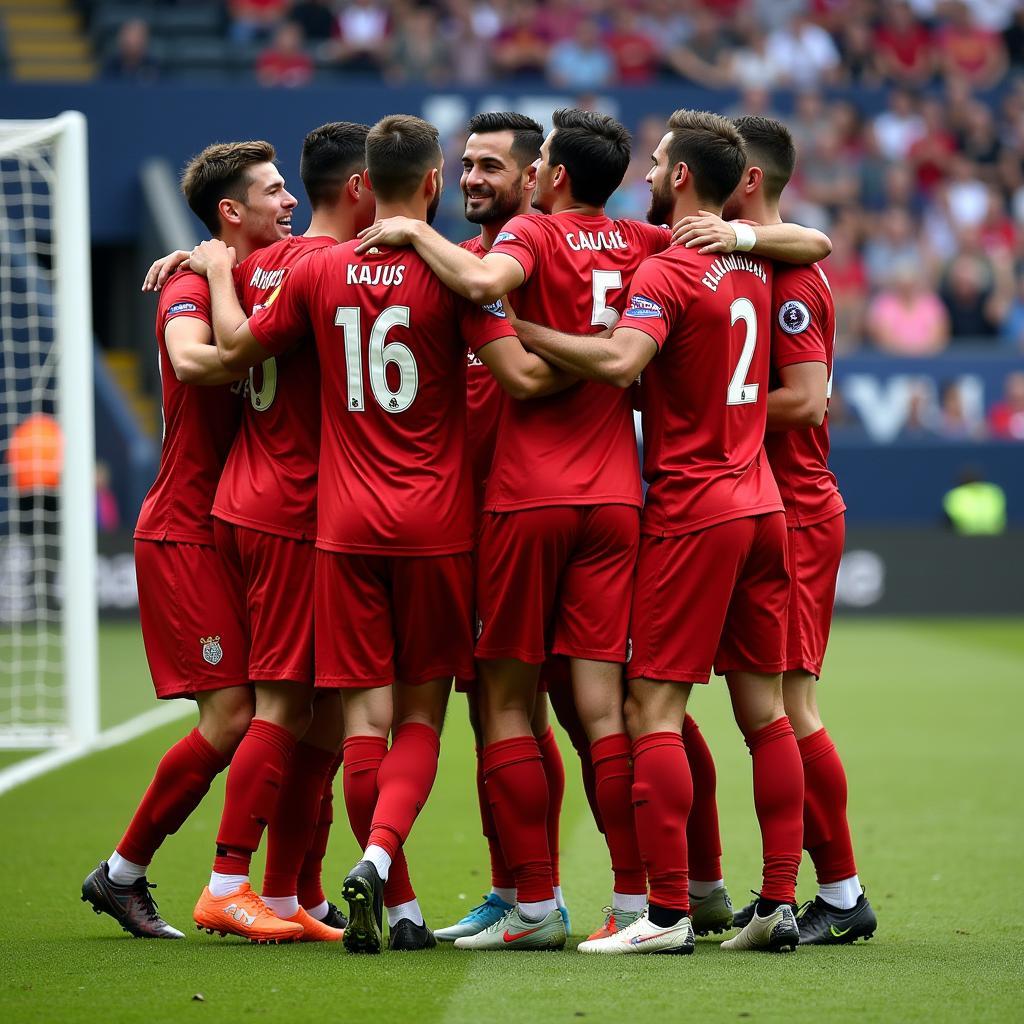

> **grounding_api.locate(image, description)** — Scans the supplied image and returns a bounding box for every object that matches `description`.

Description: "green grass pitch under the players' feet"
[0,620,1024,1024]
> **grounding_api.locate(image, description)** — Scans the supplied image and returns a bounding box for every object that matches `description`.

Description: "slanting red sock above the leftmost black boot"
[117,729,227,864]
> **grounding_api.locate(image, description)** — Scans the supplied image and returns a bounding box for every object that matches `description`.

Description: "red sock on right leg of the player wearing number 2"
[745,717,804,903]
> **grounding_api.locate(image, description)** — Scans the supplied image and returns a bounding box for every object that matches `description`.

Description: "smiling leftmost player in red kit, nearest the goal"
[82,141,302,938]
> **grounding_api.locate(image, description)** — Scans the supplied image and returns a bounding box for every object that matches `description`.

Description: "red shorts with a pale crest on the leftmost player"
[135,541,249,700]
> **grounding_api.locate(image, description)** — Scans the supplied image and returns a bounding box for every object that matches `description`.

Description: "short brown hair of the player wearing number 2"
[669,111,746,206]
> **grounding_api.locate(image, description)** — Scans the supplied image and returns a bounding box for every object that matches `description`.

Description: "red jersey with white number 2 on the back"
[620,246,782,537]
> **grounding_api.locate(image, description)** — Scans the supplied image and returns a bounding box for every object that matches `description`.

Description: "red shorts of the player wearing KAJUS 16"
[314,550,473,689]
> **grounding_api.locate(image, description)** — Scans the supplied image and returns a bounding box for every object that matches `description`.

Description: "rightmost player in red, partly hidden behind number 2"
[693,116,878,945]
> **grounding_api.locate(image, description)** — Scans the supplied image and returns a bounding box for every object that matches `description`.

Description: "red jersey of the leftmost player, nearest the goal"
[135,270,243,546]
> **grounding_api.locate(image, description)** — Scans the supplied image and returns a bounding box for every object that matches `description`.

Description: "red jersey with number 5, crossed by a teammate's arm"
[484,213,670,512]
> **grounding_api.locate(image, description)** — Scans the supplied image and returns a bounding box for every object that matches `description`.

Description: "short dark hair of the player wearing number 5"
[548,108,630,206]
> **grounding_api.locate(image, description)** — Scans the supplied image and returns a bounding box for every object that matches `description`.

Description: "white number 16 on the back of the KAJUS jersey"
[334,306,420,413]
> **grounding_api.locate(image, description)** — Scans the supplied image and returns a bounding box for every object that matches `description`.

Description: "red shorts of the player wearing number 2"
[626,512,790,683]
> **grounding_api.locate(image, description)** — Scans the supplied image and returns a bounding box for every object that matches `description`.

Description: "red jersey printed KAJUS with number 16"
[249,242,515,555]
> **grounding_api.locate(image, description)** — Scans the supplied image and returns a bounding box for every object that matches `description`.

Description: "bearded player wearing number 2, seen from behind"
[522,111,803,954]
